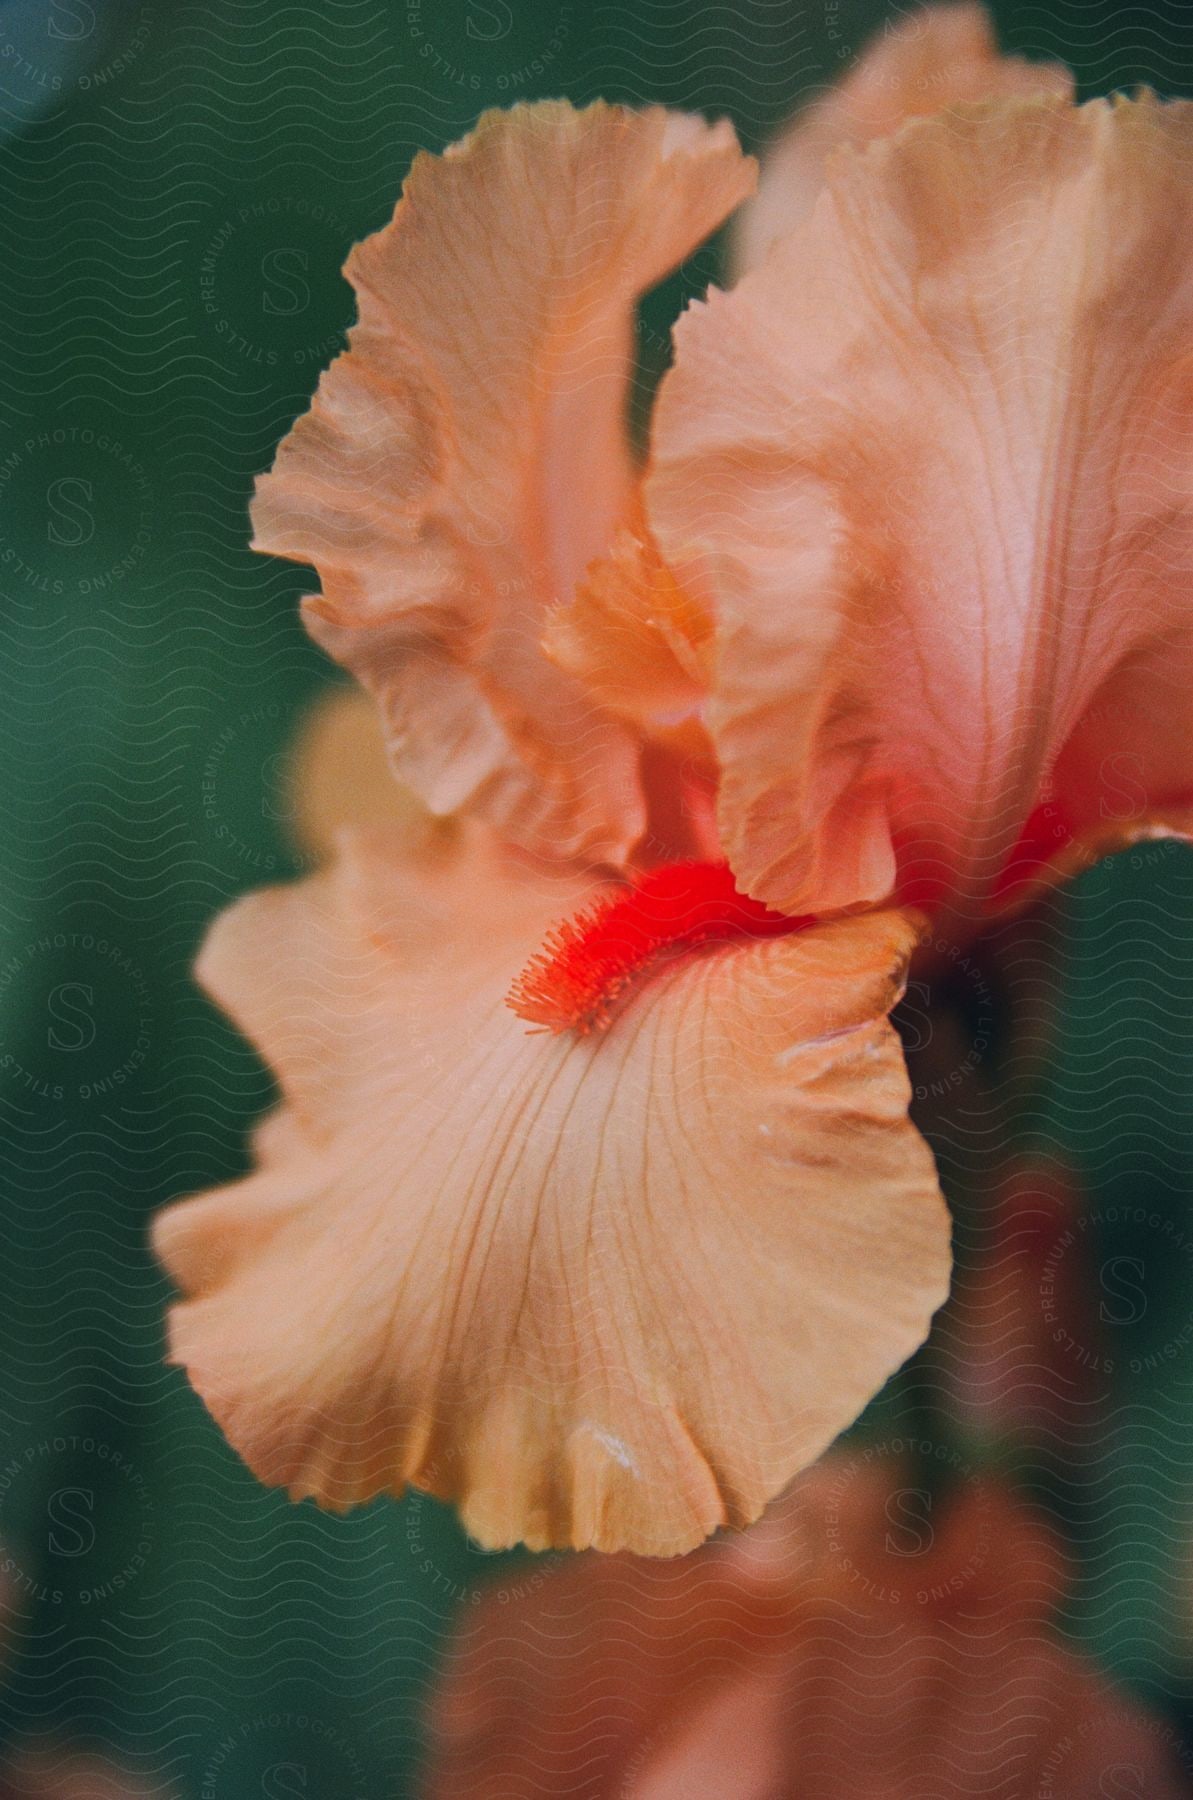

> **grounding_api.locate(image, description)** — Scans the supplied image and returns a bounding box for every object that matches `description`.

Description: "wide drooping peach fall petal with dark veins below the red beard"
[157,824,948,1555]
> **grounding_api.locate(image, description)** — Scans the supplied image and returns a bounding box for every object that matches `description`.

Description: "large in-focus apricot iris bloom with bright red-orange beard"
[157,9,1193,1555]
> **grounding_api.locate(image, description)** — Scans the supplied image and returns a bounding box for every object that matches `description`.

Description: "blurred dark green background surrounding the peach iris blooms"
[0,0,1193,1800]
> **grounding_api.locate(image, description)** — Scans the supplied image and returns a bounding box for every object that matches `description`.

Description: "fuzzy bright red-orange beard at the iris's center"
[506,862,808,1035]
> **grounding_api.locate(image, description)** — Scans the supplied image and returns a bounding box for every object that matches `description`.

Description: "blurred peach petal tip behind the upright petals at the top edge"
[734,4,1072,274]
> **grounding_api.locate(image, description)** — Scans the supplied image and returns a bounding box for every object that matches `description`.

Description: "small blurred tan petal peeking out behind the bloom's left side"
[288,688,452,862]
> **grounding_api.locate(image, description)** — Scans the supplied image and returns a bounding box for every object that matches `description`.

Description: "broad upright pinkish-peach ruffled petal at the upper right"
[648,95,1193,916]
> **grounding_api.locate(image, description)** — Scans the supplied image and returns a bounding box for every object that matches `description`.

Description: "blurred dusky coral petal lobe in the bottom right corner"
[633,1616,1189,1800]
